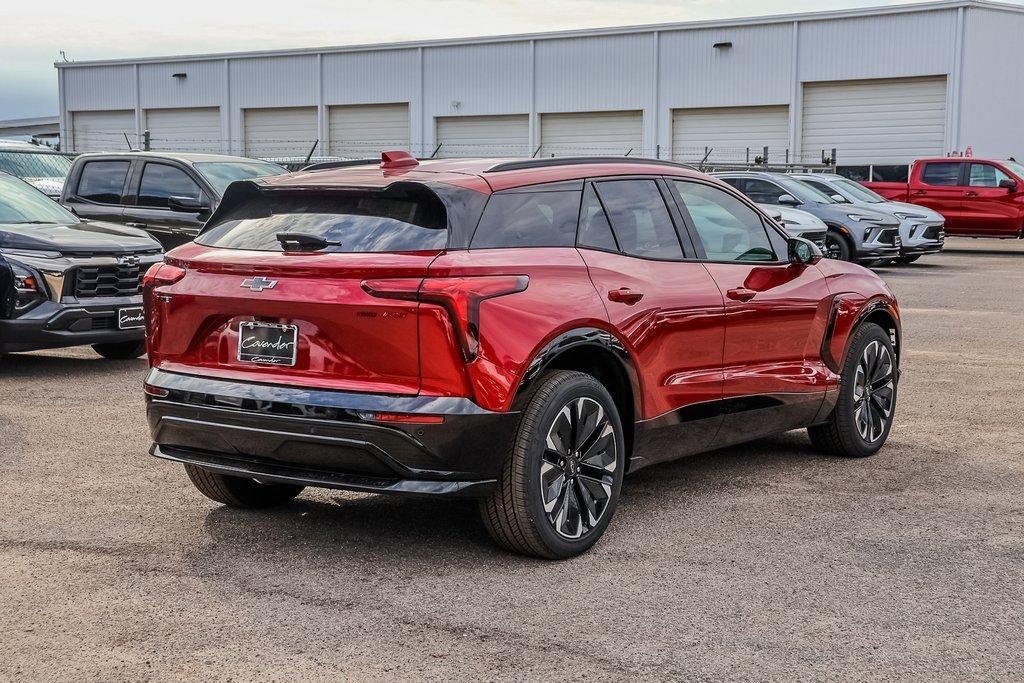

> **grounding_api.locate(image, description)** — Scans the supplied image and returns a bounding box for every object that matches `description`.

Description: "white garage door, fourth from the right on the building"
[434,114,529,158]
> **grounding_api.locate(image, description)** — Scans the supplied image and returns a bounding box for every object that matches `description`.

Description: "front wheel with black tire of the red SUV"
[807,323,899,458]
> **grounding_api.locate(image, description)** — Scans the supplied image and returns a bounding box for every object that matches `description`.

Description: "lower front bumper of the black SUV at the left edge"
[0,296,145,353]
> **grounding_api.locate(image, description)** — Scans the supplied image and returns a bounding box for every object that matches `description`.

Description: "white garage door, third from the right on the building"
[540,112,649,157]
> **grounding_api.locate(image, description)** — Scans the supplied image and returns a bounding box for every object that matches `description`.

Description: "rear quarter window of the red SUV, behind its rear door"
[470,190,580,249]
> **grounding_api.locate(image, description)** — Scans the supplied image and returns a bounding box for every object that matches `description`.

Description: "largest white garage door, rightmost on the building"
[802,76,946,165]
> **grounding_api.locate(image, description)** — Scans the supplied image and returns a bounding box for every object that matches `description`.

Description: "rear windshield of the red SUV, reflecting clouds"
[196,188,447,252]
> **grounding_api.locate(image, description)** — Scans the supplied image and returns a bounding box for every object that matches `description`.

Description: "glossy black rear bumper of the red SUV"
[146,370,518,498]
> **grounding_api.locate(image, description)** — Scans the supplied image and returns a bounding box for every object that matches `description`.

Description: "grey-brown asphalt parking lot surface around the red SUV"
[0,240,1024,680]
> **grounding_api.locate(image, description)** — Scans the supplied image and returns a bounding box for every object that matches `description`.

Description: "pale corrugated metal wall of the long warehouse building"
[59,6,1024,161]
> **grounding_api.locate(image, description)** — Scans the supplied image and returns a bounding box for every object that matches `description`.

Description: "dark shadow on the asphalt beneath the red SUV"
[189,433,821,578]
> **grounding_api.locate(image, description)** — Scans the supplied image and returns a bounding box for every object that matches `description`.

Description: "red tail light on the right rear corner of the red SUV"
[362,275,529,360]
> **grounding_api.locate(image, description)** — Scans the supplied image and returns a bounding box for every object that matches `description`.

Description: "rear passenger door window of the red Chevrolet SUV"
[597,180,683,259]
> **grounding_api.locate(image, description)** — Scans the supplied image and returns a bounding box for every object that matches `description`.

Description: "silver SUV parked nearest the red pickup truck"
[793,173,946,263]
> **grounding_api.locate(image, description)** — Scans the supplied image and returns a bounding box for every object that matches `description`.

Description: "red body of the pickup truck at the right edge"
[862,157,1024,238]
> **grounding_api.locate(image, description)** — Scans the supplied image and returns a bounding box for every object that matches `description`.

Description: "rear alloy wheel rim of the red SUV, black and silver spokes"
[540,397,617,539]
